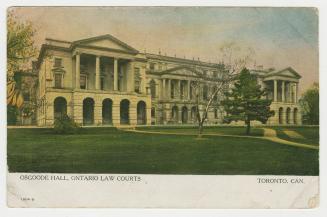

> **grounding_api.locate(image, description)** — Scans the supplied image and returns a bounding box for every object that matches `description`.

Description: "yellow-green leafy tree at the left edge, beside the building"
[7,11,36,108]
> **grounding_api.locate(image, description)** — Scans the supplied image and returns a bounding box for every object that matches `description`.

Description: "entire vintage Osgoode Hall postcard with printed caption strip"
[7,6,319,208]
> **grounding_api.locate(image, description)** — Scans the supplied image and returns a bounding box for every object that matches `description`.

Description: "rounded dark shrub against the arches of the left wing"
[54,115,81,134]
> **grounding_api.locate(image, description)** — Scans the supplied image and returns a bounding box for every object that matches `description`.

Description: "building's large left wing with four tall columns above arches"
[39,35,151,126]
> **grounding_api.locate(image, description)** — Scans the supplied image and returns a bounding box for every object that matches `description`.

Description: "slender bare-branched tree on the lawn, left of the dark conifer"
[191,43,254,137]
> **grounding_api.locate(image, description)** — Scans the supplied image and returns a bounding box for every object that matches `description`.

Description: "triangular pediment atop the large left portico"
[73,34,138,53]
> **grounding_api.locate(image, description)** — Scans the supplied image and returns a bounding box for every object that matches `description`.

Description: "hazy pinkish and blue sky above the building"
[10,7,319,92]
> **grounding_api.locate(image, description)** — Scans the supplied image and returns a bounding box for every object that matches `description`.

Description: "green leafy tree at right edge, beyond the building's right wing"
[299,83,319,124]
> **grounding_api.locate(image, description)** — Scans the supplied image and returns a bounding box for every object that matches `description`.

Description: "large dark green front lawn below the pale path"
[8,128,319,175]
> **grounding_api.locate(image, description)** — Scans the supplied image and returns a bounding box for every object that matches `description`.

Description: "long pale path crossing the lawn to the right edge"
[121,128,319,150]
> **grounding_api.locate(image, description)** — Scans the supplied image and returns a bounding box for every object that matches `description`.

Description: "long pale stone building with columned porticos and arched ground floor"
[36,35,301,126]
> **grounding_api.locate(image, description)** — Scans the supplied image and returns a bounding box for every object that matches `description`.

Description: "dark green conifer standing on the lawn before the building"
[222,68,274,134]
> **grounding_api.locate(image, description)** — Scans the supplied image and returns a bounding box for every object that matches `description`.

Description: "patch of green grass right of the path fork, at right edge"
[274,126,319,145]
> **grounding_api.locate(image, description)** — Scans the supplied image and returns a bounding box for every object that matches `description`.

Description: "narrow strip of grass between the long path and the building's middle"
[137,126,263,136]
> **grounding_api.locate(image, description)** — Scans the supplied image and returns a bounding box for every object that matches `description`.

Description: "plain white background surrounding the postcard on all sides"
[0,0,327,217]
